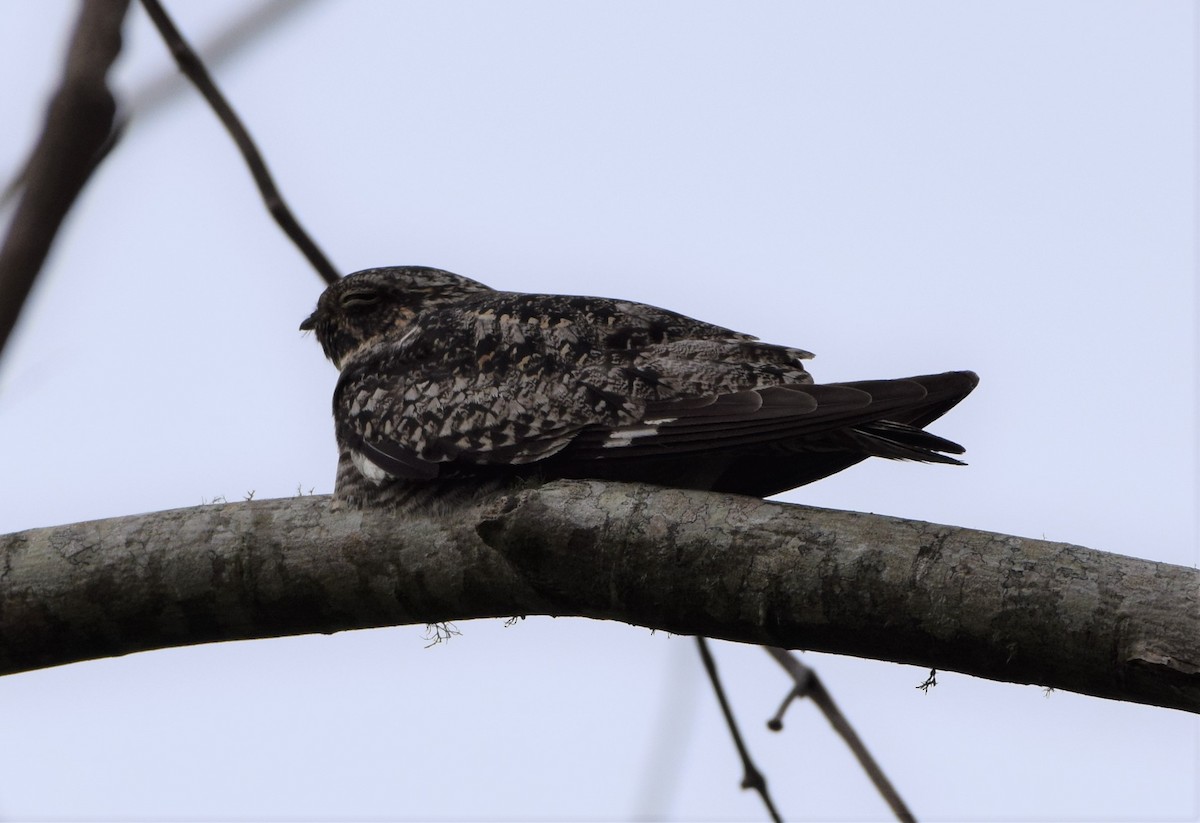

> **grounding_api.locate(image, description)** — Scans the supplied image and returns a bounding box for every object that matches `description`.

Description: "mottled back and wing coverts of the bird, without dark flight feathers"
[334,293,811,481]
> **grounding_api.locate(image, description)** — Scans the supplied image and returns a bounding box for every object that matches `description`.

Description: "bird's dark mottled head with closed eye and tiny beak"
[300,266,492,368]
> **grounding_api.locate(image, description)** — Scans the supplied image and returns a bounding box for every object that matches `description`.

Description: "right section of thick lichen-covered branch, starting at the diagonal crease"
[481,483,1200,711]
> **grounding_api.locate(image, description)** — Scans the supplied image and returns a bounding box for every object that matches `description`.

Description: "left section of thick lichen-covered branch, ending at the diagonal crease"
[0,497,540,673]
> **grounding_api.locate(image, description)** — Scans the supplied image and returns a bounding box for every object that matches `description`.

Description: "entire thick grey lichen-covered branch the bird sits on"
[0,481,1200,711]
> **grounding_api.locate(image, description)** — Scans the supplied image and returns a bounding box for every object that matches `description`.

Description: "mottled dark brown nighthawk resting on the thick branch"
[300,266,978,506]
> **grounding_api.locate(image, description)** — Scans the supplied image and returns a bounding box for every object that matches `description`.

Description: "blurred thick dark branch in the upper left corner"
[0,0,128,364]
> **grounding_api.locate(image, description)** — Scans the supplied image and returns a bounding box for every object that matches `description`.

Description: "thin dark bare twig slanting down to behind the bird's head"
[142,0,340,283]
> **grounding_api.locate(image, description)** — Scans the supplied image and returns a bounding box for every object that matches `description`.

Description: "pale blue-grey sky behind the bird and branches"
[0,0,1200,821]
